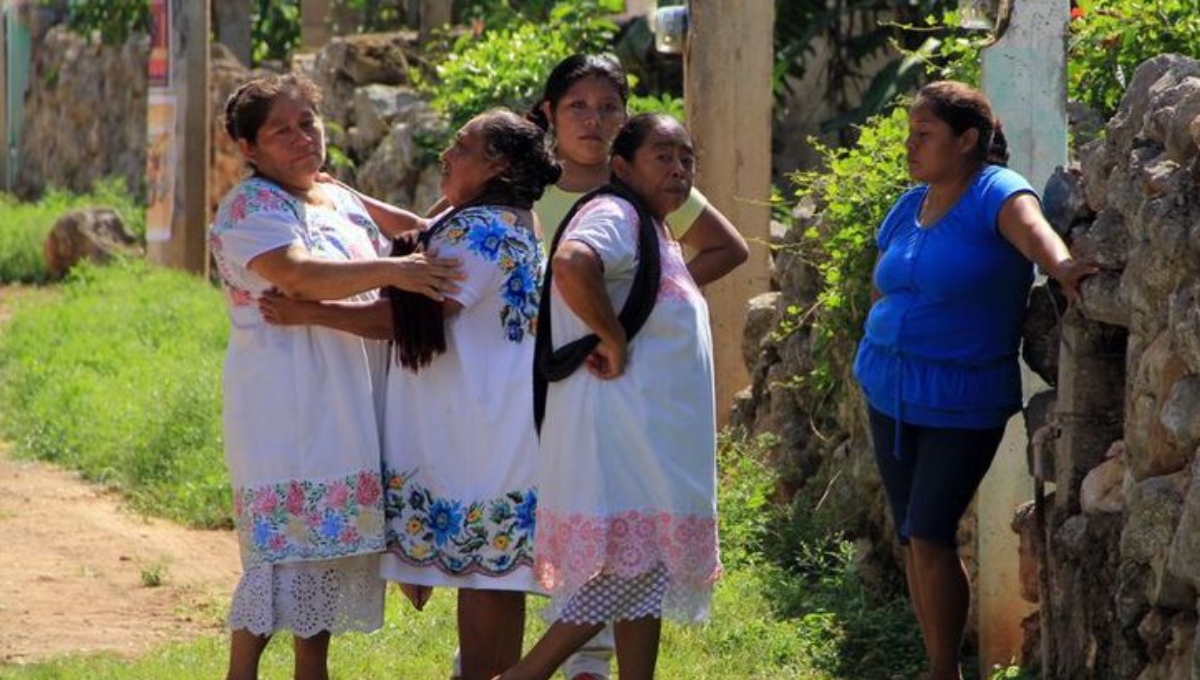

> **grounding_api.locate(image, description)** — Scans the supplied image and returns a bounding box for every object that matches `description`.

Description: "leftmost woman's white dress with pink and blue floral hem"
[210,177,389,637]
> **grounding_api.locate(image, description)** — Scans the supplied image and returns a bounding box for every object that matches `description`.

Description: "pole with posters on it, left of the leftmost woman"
[146,0,210,273]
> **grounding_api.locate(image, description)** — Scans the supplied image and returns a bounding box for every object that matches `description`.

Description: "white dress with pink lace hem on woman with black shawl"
[535,195,721,622]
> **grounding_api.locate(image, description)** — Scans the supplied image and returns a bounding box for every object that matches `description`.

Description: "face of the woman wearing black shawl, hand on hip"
[612,121,696,218]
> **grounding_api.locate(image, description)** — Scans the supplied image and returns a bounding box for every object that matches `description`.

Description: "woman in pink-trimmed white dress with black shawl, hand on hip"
[500,114,721,680]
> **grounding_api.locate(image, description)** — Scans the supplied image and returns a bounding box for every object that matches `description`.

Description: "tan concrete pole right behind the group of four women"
[684,0,775,426]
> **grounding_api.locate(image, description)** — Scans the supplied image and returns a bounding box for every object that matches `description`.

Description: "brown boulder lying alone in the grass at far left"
[43,207,143,278]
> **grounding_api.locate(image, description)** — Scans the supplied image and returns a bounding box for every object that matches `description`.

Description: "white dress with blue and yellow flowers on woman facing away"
[380,206,544,591]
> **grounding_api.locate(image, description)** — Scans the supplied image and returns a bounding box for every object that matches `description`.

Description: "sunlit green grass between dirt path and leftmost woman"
[0,263,230,526]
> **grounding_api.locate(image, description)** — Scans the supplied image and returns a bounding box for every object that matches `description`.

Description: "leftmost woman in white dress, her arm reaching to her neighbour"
[210,76,457,680]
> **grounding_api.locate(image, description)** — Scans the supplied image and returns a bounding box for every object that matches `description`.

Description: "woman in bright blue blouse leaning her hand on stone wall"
[854,82,1096,680]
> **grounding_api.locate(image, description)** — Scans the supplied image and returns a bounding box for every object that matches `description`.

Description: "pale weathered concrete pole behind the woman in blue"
[977,0,1070,675]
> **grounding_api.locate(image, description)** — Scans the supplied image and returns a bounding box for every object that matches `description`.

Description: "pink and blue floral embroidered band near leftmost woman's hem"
[234,470,384,568]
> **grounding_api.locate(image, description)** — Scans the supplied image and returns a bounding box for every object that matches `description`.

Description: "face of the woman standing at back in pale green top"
[542,76,626,166]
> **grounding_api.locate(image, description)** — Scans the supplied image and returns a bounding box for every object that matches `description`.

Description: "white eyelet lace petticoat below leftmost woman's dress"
[229,554,385,638]
